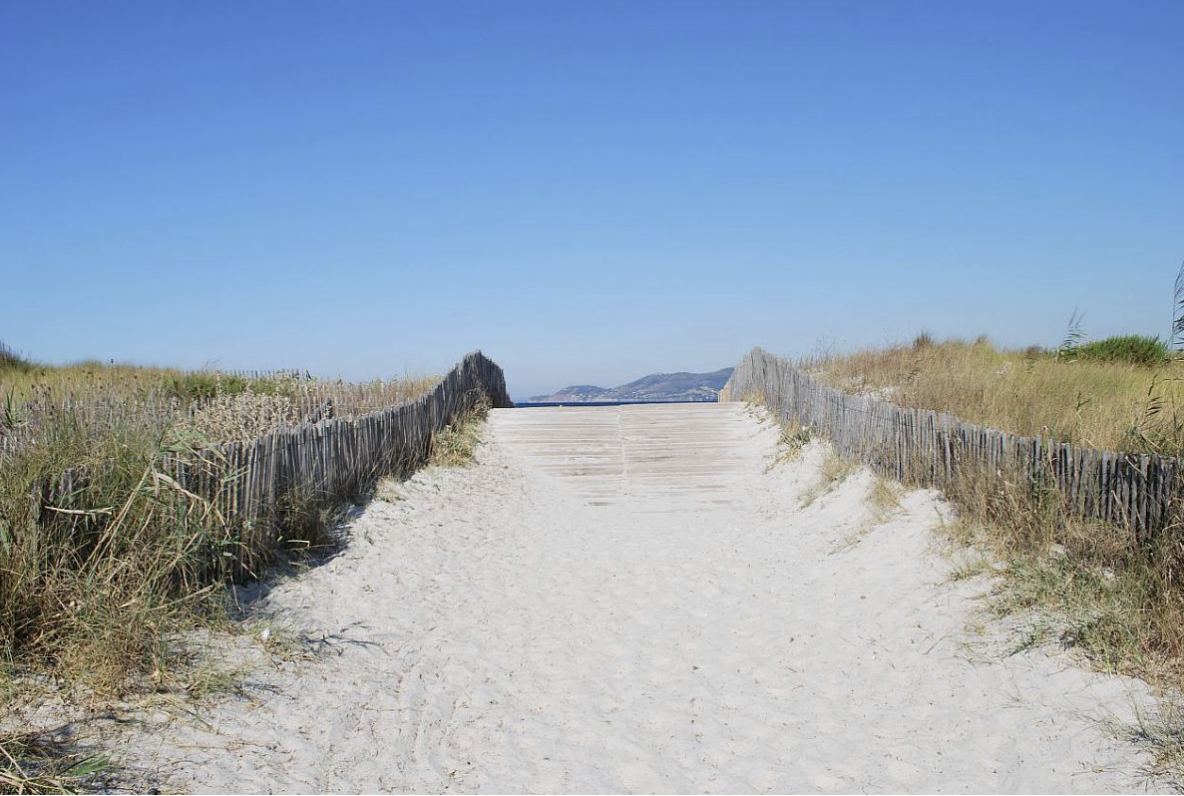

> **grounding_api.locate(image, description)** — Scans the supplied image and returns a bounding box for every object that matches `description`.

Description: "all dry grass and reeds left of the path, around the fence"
[0,346,436,720]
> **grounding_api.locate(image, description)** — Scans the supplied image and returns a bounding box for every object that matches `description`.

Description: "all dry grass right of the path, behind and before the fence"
[810,335,1184,776]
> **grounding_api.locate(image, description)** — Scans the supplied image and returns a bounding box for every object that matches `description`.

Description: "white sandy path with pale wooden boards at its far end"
[141,404,1165,792]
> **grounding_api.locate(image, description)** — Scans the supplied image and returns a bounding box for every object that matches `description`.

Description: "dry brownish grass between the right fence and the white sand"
[945,459,1184,682]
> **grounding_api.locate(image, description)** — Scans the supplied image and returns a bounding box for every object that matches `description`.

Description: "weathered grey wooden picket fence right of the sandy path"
[720,348,1184,539]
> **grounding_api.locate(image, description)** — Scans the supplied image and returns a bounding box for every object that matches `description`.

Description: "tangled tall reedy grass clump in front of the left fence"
[0,423,310,695]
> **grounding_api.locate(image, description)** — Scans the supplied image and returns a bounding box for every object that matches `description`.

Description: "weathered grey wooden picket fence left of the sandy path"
[40,352,513,524]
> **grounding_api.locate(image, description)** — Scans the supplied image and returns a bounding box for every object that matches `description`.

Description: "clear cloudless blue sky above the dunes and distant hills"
[0,0,1184,397]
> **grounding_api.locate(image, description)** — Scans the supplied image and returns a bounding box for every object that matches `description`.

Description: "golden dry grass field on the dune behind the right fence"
[810,335,1184,455]
